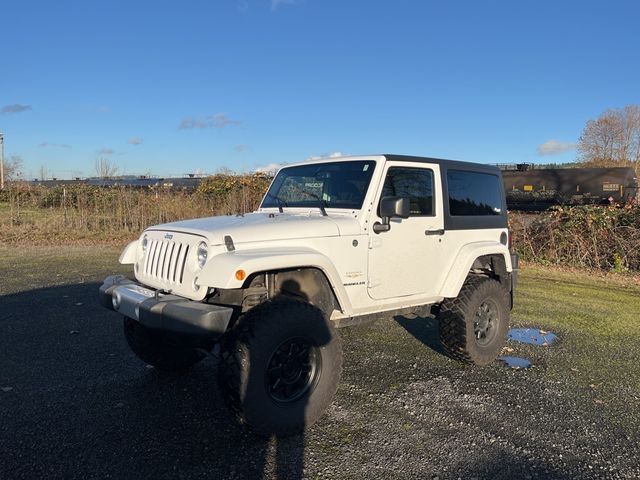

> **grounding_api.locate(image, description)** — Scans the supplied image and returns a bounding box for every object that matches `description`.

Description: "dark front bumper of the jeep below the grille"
[99,275,233,339]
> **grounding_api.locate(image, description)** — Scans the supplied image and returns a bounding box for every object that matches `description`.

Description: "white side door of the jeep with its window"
[368,162,447,300]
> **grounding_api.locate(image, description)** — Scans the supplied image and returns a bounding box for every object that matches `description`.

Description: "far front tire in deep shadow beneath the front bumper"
[124,317,206,372]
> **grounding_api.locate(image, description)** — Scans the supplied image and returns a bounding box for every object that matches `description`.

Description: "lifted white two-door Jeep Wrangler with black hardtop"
[100,155,517,435]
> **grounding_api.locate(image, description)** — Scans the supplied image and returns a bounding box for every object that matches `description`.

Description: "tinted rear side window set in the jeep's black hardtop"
[447,170,502,215]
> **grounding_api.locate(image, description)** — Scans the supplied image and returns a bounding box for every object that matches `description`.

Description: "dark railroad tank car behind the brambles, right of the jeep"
[502,165,638,210]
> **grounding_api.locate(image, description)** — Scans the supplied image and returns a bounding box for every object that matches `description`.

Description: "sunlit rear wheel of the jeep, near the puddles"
[438,275,509,365]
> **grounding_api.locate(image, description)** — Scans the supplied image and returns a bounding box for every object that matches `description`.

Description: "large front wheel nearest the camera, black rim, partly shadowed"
[219,299,342,436]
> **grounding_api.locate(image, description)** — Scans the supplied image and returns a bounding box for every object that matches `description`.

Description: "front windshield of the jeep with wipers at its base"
[262,160,376,209]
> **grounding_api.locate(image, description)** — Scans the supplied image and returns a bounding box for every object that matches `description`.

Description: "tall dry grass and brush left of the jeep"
[0,175,269,245]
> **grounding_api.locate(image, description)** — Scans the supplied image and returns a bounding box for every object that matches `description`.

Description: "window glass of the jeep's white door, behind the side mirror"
[382,167,434,217]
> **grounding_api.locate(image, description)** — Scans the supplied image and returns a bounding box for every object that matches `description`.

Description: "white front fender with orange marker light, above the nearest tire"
[197,247,352,313]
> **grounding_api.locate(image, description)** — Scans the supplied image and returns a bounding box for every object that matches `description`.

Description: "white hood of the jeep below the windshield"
[147,212,360,245]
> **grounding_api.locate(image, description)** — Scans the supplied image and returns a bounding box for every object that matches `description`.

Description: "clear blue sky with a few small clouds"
[0,0,640,178]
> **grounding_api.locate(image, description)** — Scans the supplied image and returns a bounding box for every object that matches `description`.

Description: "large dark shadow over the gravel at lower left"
[0,283,304,479]
